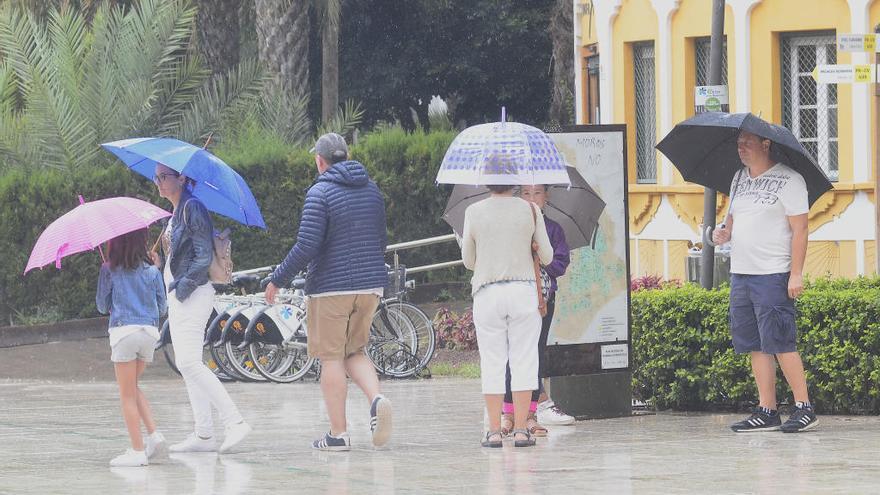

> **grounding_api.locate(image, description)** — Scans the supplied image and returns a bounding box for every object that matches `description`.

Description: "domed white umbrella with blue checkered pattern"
[437,117,569,185]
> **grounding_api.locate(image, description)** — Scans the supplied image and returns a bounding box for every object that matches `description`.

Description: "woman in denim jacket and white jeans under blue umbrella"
[153,163,251,452]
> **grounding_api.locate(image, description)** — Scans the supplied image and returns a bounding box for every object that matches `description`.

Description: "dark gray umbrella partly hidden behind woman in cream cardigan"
[443,167,605,249]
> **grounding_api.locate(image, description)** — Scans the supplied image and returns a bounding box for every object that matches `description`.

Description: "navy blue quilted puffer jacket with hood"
[272,161,388,294]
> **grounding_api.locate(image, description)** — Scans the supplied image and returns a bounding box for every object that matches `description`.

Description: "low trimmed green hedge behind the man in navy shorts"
[631,278,880,414]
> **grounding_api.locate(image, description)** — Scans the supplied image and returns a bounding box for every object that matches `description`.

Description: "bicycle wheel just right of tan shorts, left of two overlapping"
[365,304,419,378]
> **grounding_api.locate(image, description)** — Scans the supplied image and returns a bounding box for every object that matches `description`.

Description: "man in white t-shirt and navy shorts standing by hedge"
[712,131,819,433]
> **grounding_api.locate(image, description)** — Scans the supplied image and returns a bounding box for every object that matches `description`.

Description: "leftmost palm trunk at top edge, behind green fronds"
[196,0,241,74]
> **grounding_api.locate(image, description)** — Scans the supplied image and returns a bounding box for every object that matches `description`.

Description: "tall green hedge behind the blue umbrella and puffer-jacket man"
[0,127,460,325]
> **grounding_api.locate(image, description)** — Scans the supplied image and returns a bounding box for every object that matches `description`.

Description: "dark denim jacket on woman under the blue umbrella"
[164,191,214,301]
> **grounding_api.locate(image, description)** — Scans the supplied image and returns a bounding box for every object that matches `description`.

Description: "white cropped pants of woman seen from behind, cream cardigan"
[474,282,541,394]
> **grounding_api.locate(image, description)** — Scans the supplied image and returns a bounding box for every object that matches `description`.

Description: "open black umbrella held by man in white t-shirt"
[657,112,832,206]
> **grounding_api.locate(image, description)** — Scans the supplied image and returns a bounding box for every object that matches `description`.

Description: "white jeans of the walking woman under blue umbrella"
[168,283,242,438]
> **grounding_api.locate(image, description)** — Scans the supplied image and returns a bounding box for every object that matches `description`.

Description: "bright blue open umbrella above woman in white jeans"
[101,138,266,229]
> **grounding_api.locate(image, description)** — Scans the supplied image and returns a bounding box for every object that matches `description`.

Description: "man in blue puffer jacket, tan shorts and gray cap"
[266,133,391,450]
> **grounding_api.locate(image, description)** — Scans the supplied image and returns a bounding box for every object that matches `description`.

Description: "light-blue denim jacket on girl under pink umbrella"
[95,263,167,328]
